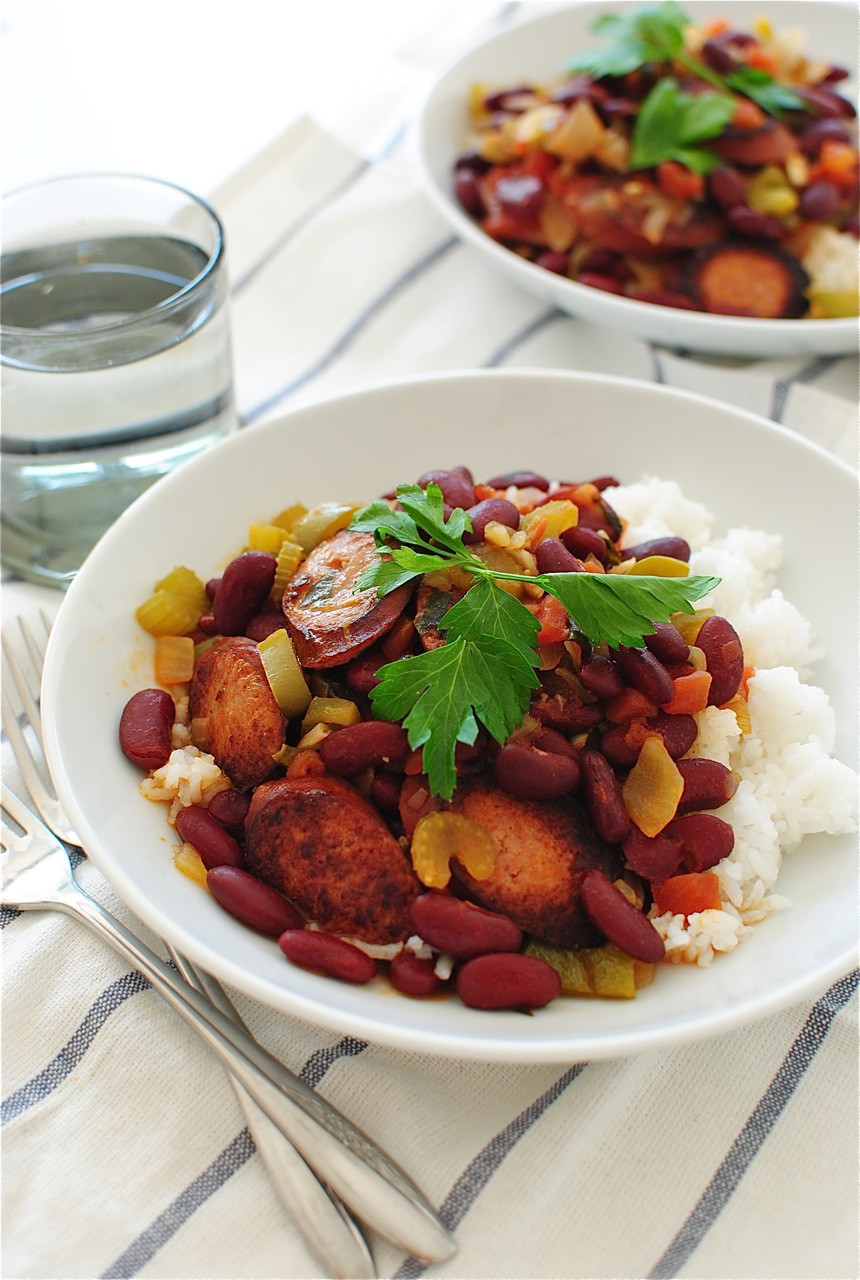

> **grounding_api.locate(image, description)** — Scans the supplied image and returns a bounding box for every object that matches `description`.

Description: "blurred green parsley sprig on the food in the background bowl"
[568,0,805,174]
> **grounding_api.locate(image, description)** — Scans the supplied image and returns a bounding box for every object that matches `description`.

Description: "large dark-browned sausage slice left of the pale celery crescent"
[244,777,420,945]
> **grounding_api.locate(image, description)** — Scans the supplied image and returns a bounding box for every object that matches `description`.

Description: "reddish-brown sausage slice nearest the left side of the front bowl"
[188,636,284,791]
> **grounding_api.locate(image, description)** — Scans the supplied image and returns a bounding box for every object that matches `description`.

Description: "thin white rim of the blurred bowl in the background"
[410,0,860,355]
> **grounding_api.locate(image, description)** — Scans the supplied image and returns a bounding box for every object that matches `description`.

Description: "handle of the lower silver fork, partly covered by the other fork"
[168,943,376,1280]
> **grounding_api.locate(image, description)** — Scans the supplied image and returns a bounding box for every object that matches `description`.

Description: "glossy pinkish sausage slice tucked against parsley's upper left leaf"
[284,529,410,667]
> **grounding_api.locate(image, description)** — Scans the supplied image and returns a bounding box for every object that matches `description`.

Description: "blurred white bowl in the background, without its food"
[412,0,859,357]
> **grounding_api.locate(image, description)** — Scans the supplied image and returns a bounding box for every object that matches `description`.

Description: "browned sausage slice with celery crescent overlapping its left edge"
[452,778,621,947]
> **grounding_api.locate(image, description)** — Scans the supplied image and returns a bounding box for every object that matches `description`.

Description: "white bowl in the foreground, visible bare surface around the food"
[44,370,857,1062]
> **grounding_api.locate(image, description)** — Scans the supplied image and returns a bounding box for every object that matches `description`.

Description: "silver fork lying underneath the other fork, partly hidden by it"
[0,611,375,1280]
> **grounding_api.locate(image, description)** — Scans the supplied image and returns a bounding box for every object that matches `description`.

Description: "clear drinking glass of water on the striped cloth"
[0,174,237,588]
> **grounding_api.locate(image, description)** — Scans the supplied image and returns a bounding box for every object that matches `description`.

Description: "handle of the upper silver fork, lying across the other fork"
[59,886,457,1262]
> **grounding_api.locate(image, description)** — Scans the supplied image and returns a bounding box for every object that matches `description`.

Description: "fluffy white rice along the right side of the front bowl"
[607,479,857,965]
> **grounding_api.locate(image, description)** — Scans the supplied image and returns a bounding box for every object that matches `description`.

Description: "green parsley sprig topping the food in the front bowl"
[351,484,719,800]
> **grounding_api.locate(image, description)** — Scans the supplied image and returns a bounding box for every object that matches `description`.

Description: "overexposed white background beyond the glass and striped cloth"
[0,0,498,195]
